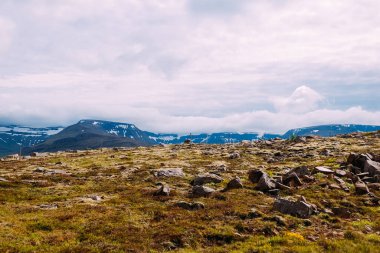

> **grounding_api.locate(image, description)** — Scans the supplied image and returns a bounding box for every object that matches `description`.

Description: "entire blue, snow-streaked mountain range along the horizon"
[0,120,380,156]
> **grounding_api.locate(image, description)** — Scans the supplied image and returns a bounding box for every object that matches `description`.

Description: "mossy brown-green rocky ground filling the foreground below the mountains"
[0,132,380,252]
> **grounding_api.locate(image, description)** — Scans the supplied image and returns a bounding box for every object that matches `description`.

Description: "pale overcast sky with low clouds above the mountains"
[0,0,380,133]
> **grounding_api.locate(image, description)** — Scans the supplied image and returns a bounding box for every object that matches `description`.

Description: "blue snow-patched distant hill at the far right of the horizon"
[282,124,380,139]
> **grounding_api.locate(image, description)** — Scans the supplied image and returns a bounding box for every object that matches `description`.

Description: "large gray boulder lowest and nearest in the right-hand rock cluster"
[273,198,314,218]
